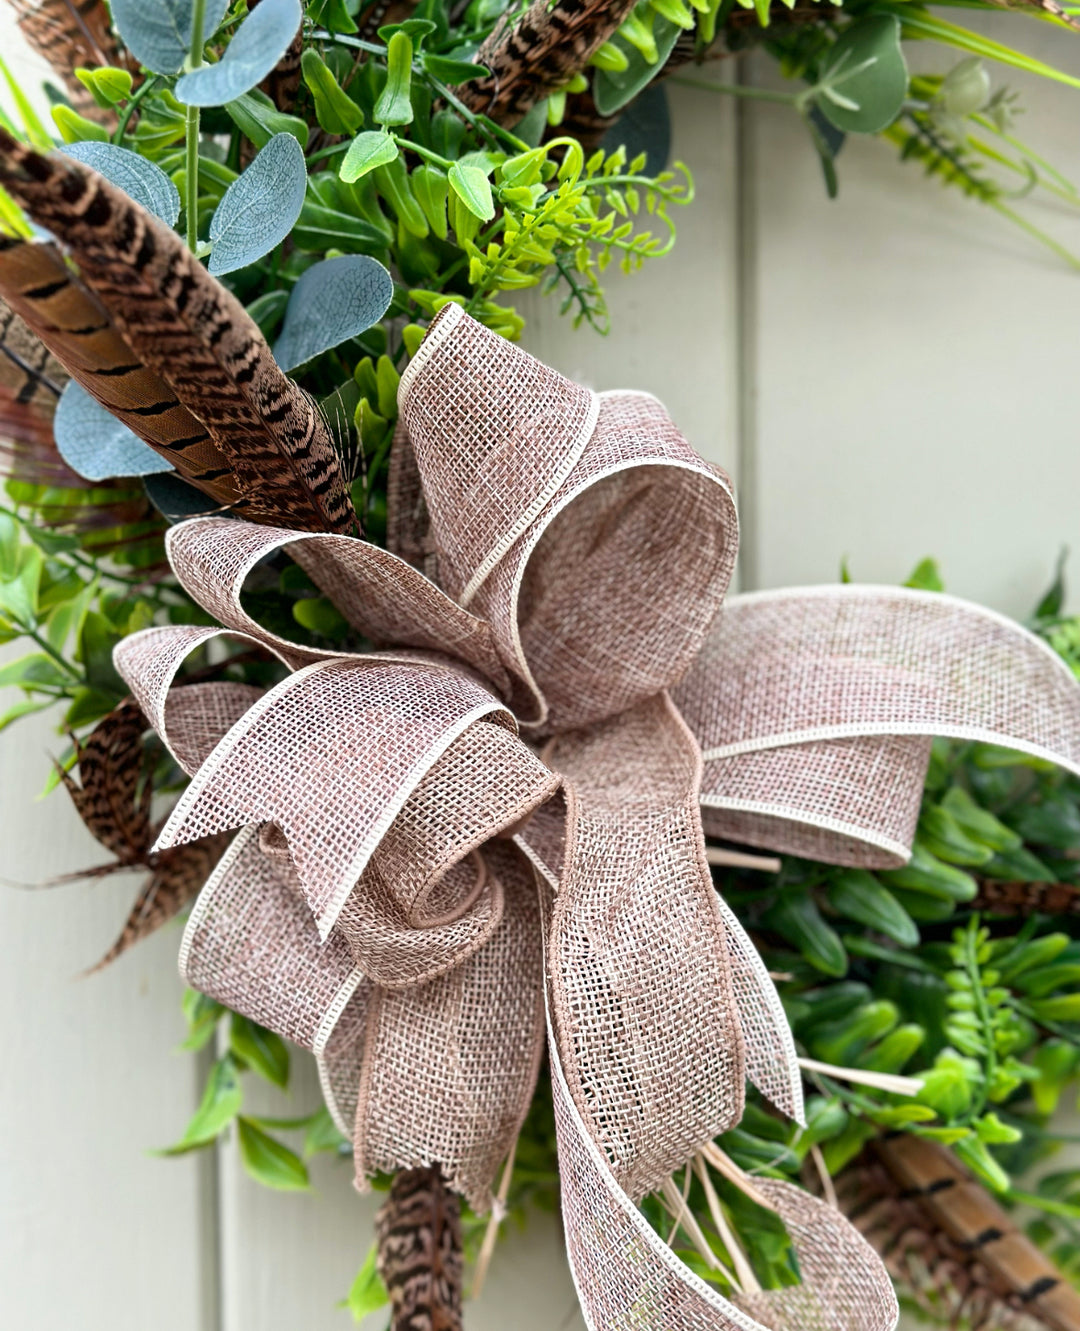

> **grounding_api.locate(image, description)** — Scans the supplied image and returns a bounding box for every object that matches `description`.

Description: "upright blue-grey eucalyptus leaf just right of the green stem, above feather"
[209,134,308,277]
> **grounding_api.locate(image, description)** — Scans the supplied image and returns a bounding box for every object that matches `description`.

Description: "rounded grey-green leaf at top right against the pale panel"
[815,13,908,134]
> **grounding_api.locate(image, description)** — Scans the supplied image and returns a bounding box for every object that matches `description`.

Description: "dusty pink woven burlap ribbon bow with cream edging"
[116,305,1080,1331]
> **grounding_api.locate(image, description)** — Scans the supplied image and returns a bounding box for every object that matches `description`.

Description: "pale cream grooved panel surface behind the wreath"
[0,9,1080,1331]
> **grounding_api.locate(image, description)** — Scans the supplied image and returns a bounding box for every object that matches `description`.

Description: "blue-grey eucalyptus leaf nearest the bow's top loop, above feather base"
[274,254,394,370]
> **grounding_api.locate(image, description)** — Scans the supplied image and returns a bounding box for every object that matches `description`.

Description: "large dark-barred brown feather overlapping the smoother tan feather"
[0,130,360,532]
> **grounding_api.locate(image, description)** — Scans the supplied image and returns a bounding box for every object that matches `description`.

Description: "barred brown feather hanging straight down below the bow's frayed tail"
[376,1166,462,1331]
